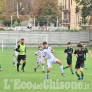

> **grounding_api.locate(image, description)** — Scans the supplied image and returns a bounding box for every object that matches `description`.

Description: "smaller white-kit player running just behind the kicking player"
[34,46,45,73]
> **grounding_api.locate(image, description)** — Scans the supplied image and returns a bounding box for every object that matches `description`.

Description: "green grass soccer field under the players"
[0,47,92,92]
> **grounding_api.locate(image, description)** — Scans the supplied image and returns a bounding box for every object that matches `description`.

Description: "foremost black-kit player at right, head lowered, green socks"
[74,43,85,80]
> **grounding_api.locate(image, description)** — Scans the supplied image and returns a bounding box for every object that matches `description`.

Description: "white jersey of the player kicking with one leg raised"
[43,47,55,60]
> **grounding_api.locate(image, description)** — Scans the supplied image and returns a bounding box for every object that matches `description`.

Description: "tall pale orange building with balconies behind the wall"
[60,0,81,29]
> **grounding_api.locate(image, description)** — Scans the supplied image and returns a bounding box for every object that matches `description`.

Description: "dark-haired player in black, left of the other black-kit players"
[64,42,74,74]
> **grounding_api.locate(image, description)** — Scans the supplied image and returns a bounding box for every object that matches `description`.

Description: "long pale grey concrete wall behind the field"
[0,31,92,47]
